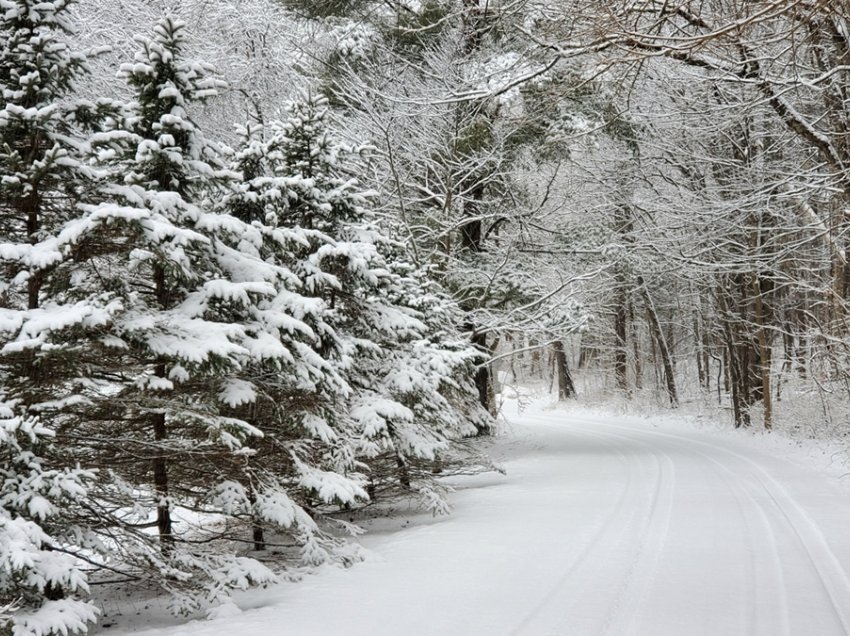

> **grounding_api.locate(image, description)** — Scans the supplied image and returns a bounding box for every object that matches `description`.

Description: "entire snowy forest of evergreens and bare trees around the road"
[0,0,850,636]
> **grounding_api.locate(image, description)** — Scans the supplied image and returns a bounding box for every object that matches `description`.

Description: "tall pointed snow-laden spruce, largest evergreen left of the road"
[5,19,312,610]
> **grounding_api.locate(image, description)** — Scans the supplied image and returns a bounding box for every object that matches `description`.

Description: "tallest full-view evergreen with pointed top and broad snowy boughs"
[62,18,366,611]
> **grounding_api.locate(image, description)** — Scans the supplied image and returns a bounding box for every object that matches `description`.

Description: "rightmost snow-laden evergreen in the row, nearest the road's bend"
[232,95,487,509]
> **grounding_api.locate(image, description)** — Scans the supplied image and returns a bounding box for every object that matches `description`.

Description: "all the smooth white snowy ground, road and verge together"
[103,404,850,636]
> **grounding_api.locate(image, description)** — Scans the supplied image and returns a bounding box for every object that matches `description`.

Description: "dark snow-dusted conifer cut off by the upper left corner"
[0,0,113,310]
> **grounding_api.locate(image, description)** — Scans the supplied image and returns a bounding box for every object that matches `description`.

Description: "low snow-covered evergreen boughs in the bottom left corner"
[0,400,97,636]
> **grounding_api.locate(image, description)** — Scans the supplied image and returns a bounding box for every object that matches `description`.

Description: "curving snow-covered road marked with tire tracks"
[510,418,850,635]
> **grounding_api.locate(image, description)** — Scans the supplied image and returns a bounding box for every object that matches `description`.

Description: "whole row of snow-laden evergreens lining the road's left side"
[0,0,490,634]
